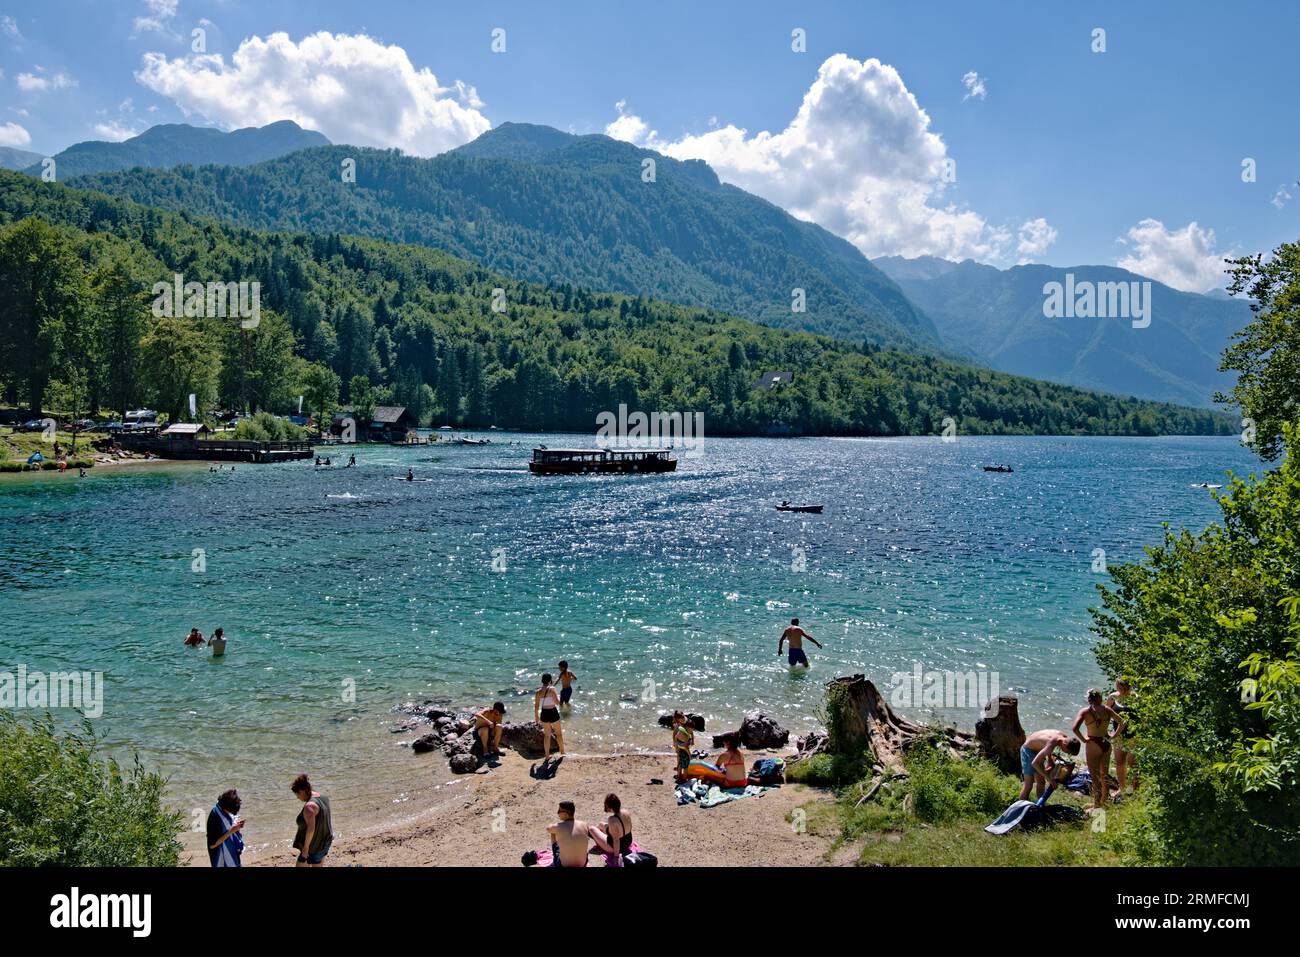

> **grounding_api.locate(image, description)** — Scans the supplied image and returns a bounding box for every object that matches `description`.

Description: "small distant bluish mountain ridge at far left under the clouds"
[23,120,329,181]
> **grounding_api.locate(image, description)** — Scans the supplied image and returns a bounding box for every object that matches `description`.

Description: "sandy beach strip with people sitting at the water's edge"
[236,750,831,867]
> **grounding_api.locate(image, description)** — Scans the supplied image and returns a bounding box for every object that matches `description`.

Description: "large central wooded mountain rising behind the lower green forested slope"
[73,124,939,351]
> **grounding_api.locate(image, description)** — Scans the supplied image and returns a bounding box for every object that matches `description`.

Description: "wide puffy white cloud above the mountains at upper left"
[135,31,491,156]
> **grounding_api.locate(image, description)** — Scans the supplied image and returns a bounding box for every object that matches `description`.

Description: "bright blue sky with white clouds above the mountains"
[0,0,1300,289]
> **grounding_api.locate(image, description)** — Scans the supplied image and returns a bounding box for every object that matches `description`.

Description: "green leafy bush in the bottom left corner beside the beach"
[0,711,185,867]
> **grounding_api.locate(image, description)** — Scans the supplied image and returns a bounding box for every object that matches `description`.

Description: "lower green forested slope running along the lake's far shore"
[0,172,1232,436]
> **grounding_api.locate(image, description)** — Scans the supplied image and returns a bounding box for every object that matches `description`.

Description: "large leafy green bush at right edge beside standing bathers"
[1093,426,1300,865]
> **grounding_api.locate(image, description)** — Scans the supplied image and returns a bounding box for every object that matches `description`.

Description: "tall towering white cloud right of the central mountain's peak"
[606,53,1011,260]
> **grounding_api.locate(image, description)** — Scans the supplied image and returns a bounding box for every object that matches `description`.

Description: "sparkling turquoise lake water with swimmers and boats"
[0,434,1257,842]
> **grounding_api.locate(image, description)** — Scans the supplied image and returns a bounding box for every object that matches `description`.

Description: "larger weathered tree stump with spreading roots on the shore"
[827,675,975,775]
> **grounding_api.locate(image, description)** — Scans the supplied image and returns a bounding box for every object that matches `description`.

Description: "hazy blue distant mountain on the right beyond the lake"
[876,256,1251,407]
